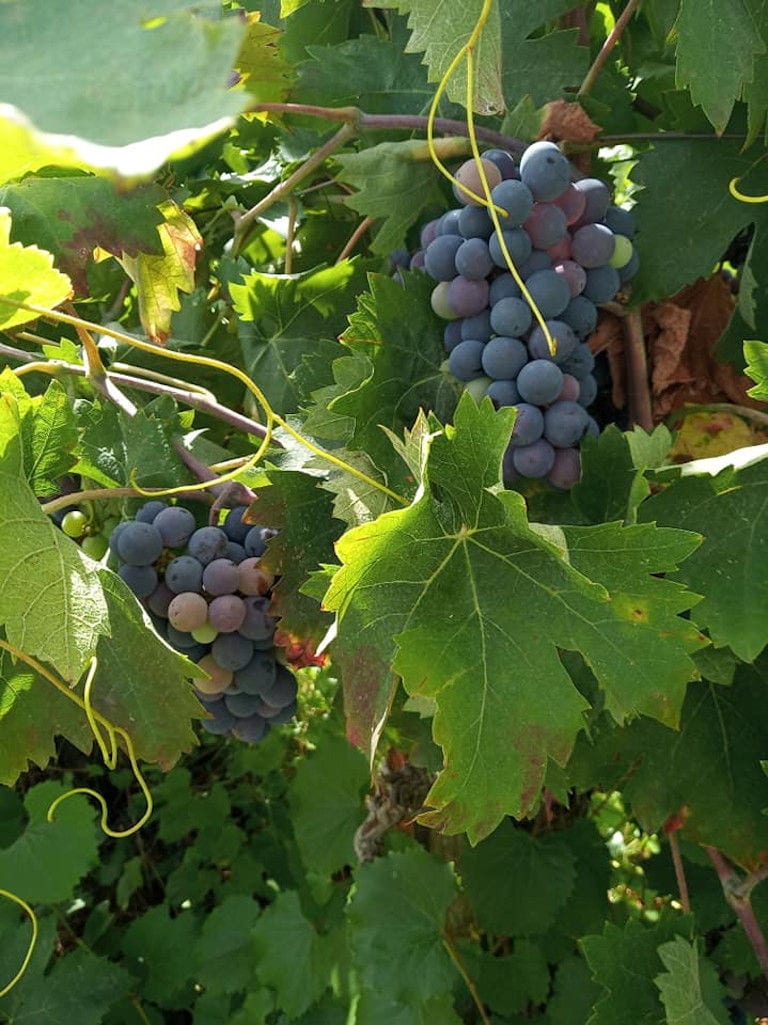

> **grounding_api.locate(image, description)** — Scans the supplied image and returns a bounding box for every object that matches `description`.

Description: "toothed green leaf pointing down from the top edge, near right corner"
[675,0,766,133]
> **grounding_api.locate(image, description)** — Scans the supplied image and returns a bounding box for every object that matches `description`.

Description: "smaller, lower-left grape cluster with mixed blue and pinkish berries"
[110,501,297,744]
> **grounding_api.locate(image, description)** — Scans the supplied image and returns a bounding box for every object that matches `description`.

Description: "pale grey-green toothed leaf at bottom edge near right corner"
[654,936,730,1025]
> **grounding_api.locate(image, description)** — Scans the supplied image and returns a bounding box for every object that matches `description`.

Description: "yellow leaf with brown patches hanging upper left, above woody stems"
[120,201,203,342]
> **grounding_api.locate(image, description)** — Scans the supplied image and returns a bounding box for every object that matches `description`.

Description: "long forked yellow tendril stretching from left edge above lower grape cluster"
[0,295,410,506]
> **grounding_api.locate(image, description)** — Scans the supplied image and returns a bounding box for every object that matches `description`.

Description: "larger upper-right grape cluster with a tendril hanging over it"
[410,142,639,488]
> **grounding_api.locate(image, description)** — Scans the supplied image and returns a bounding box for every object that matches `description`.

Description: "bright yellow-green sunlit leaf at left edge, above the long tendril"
[0,208,72,331]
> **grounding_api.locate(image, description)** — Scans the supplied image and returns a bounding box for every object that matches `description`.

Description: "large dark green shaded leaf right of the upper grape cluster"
[631,139,768,301]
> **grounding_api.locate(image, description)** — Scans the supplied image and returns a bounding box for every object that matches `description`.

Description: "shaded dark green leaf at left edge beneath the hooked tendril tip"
[0,780,98,904]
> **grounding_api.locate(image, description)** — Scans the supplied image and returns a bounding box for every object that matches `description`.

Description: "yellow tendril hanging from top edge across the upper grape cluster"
[427,0,557,356]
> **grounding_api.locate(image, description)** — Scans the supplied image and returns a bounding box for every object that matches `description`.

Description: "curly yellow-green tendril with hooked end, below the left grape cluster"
[0,639,154,839]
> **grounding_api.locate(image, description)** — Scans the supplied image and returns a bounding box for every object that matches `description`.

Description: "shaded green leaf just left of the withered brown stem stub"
[289,737,370,875]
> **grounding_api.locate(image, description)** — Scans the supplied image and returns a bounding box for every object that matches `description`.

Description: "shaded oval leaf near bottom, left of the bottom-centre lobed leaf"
[253,890,328,1021]
